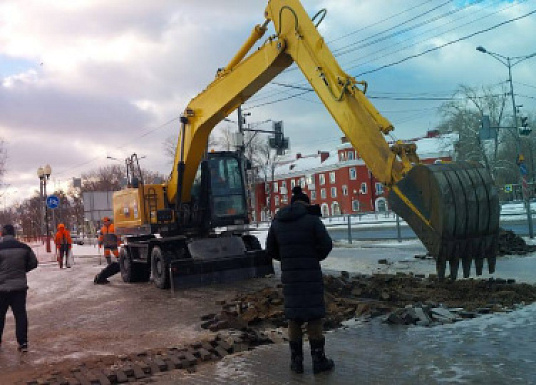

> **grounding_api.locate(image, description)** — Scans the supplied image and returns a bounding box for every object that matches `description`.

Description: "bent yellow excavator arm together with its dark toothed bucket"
[167,0,499,278]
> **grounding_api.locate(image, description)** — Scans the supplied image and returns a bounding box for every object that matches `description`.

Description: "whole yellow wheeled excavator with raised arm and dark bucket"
[113,0,499,288]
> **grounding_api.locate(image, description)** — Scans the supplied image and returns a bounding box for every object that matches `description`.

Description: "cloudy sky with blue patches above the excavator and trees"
[0,0,536,205]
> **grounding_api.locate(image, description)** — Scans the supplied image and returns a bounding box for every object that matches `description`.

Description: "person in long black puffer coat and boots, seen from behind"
[266,186,335,374]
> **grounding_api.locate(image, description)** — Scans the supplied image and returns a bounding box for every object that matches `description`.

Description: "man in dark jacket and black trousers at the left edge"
[0,224,38,353]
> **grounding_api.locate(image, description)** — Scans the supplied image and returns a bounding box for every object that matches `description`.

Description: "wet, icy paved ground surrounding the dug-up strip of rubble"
[0,241,536,385]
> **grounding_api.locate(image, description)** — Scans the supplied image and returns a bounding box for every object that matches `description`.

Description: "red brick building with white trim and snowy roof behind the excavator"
[252,131,453,221]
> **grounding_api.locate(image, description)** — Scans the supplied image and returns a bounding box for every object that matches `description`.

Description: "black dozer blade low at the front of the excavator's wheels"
[171,237,274,290]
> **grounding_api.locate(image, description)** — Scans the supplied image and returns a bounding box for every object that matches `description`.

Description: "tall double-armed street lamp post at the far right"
[476,46,536,238]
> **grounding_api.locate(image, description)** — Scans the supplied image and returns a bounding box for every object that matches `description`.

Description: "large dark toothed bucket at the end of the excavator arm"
[388,162,500,280]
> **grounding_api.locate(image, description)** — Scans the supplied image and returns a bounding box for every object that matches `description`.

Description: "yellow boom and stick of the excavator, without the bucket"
[167,0,416,206]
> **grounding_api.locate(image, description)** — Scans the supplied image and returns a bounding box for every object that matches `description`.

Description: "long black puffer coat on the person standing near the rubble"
[266,202,333,321]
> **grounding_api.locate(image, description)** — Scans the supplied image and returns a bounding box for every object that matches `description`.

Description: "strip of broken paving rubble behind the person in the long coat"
[201,272,536,331]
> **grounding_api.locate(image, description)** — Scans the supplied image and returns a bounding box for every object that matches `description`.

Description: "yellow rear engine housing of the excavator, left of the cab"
[113,184,165,233]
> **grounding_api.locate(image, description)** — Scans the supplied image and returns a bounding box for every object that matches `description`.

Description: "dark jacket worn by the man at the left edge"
[0,235,37,293]
